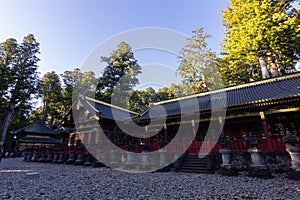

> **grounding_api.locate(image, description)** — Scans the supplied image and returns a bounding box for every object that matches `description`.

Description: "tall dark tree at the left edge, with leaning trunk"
[0,34,39,141]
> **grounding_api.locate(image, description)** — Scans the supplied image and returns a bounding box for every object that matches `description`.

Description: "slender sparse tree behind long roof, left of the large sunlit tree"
[177,28,222,94]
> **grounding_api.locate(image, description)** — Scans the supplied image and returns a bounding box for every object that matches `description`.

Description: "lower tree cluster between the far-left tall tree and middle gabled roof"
[29,68,98,126]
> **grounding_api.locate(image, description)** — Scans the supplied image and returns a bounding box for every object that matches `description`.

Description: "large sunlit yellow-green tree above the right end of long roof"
[220,0,300,85]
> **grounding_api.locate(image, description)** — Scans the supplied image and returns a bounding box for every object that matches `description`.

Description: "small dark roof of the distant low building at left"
[15,122,58,135]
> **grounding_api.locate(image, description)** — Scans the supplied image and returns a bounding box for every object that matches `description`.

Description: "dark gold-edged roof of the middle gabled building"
[80,97,138,121]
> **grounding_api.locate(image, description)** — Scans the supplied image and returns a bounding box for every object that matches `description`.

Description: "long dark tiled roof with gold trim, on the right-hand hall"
[134,73,300,120]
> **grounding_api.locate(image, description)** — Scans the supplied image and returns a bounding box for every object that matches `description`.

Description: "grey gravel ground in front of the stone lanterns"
[0,158,300,200]
